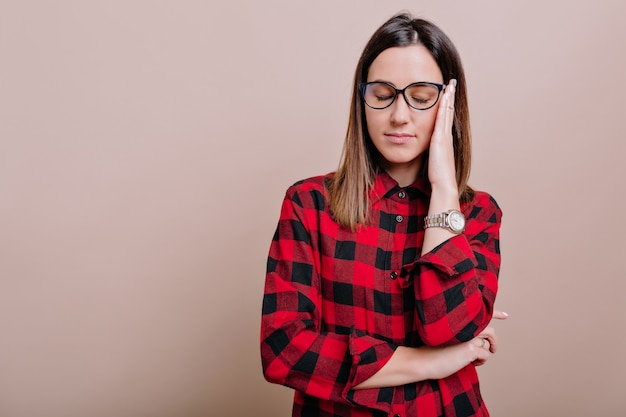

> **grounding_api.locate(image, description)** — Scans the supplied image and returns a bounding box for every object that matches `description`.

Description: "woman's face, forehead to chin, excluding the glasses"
[365,45,443,183]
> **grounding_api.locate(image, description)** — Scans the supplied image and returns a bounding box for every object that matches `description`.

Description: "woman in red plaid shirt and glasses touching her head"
[261,14,505,417]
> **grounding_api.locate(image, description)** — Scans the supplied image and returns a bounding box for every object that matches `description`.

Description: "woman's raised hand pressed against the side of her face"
[428,79,458,192]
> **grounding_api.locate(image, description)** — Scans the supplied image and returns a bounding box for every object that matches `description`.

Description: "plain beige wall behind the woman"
[0,0,626,417]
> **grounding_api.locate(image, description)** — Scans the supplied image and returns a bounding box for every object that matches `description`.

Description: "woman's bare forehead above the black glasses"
[367,45,443,87]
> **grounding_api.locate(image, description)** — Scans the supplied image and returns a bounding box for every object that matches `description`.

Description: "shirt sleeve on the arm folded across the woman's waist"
[261,187,397,411]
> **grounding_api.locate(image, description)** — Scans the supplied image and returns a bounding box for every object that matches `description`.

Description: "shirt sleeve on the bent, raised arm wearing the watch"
[402,193,502,346]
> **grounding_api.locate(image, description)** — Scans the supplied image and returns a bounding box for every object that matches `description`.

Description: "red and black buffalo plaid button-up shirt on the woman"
[261,173,501,417]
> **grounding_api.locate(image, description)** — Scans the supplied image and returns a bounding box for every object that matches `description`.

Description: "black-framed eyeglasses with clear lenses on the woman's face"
[361,81,443,110]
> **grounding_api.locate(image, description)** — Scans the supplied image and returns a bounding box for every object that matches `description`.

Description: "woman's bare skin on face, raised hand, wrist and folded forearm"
[356,45,508,389]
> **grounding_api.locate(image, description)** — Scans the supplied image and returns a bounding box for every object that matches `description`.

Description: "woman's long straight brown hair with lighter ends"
[327,13,474,230]
